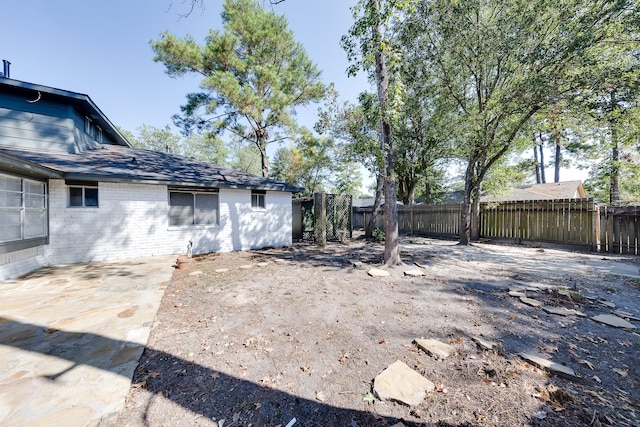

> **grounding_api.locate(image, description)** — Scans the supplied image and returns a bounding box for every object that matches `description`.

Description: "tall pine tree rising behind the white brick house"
[151,0,327,177]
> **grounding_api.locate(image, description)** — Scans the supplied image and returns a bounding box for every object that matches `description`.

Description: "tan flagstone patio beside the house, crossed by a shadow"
[0,255,175,426]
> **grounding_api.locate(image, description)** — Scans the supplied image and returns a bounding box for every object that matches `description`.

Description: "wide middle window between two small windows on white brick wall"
[169,190,219,227]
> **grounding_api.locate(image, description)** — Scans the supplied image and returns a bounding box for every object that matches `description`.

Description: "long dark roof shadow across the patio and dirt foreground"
[0,317,478,427]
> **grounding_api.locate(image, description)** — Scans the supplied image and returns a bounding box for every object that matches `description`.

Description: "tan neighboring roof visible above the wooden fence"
[480,180,587,202]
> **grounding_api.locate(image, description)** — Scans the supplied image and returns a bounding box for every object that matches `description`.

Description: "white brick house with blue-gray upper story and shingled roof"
[0,77,301,280]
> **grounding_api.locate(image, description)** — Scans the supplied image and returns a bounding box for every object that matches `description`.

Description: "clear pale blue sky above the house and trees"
[0,0,588,187]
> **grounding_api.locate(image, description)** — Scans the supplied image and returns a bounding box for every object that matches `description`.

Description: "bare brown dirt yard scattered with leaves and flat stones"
[118,238,640,427]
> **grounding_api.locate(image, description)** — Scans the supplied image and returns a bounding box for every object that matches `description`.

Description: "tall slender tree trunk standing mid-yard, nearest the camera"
[370,0,402,265]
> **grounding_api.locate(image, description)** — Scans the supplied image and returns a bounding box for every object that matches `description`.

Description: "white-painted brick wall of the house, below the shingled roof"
[0,180,291,280]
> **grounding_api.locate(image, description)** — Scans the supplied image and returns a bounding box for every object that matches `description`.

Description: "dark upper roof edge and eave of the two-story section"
[0,78,131,147]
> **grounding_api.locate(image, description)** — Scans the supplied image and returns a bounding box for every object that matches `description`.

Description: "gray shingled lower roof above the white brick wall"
[0,145,303,192]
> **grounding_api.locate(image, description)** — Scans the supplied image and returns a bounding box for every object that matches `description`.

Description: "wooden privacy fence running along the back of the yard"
[354,199,640,255]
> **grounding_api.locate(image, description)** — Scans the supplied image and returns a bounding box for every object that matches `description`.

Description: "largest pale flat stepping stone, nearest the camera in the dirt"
[373,360,435,406]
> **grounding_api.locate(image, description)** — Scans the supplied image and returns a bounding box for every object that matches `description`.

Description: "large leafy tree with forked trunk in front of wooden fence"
[403,0,637,244]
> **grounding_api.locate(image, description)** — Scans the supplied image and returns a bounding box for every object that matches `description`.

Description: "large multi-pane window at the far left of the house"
[0,174,48,249]
